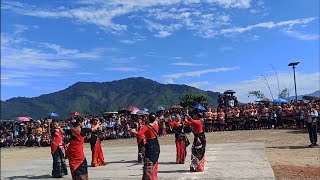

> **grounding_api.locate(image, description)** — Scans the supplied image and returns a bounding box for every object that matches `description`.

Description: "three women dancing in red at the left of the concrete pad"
[51,117,106,180]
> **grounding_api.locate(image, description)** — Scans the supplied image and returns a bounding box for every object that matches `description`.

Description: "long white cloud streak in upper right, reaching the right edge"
[220,17,318,35]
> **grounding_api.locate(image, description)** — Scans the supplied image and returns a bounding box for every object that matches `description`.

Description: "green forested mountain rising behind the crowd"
[1,77,220,119]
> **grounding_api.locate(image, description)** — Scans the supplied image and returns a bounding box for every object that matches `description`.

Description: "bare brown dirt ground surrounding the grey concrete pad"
[1,129,320,180]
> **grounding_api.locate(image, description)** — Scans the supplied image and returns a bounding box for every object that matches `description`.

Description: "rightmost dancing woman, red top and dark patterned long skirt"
[185,112,206,172]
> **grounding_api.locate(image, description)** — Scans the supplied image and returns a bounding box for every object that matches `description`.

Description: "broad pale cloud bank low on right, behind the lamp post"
[210,72,320,102]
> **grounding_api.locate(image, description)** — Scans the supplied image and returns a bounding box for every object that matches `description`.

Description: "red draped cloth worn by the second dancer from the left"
[67,129,85,171]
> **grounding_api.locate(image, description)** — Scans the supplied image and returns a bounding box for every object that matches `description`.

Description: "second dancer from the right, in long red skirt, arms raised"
[169,114,190,164]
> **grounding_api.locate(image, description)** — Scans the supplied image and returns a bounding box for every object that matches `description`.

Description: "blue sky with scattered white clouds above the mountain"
[1,0,320,102]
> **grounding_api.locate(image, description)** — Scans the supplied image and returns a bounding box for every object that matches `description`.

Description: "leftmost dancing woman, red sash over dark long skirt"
[51,122,68,178]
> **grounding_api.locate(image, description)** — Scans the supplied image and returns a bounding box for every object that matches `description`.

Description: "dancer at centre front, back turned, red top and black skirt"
[129,113,160,180]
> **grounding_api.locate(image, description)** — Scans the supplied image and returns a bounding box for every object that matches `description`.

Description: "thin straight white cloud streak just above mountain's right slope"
[163,67,239,79]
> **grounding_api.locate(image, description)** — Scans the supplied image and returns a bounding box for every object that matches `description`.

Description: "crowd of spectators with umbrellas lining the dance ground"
[0,96,320,147]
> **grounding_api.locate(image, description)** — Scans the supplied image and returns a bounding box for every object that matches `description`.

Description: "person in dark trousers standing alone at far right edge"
[307,107,319,147]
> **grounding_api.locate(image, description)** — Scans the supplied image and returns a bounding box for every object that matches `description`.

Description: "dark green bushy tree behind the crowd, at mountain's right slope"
[180,94,208,107]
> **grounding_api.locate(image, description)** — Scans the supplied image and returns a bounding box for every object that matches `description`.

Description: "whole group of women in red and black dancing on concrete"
[51,111,206,180]
